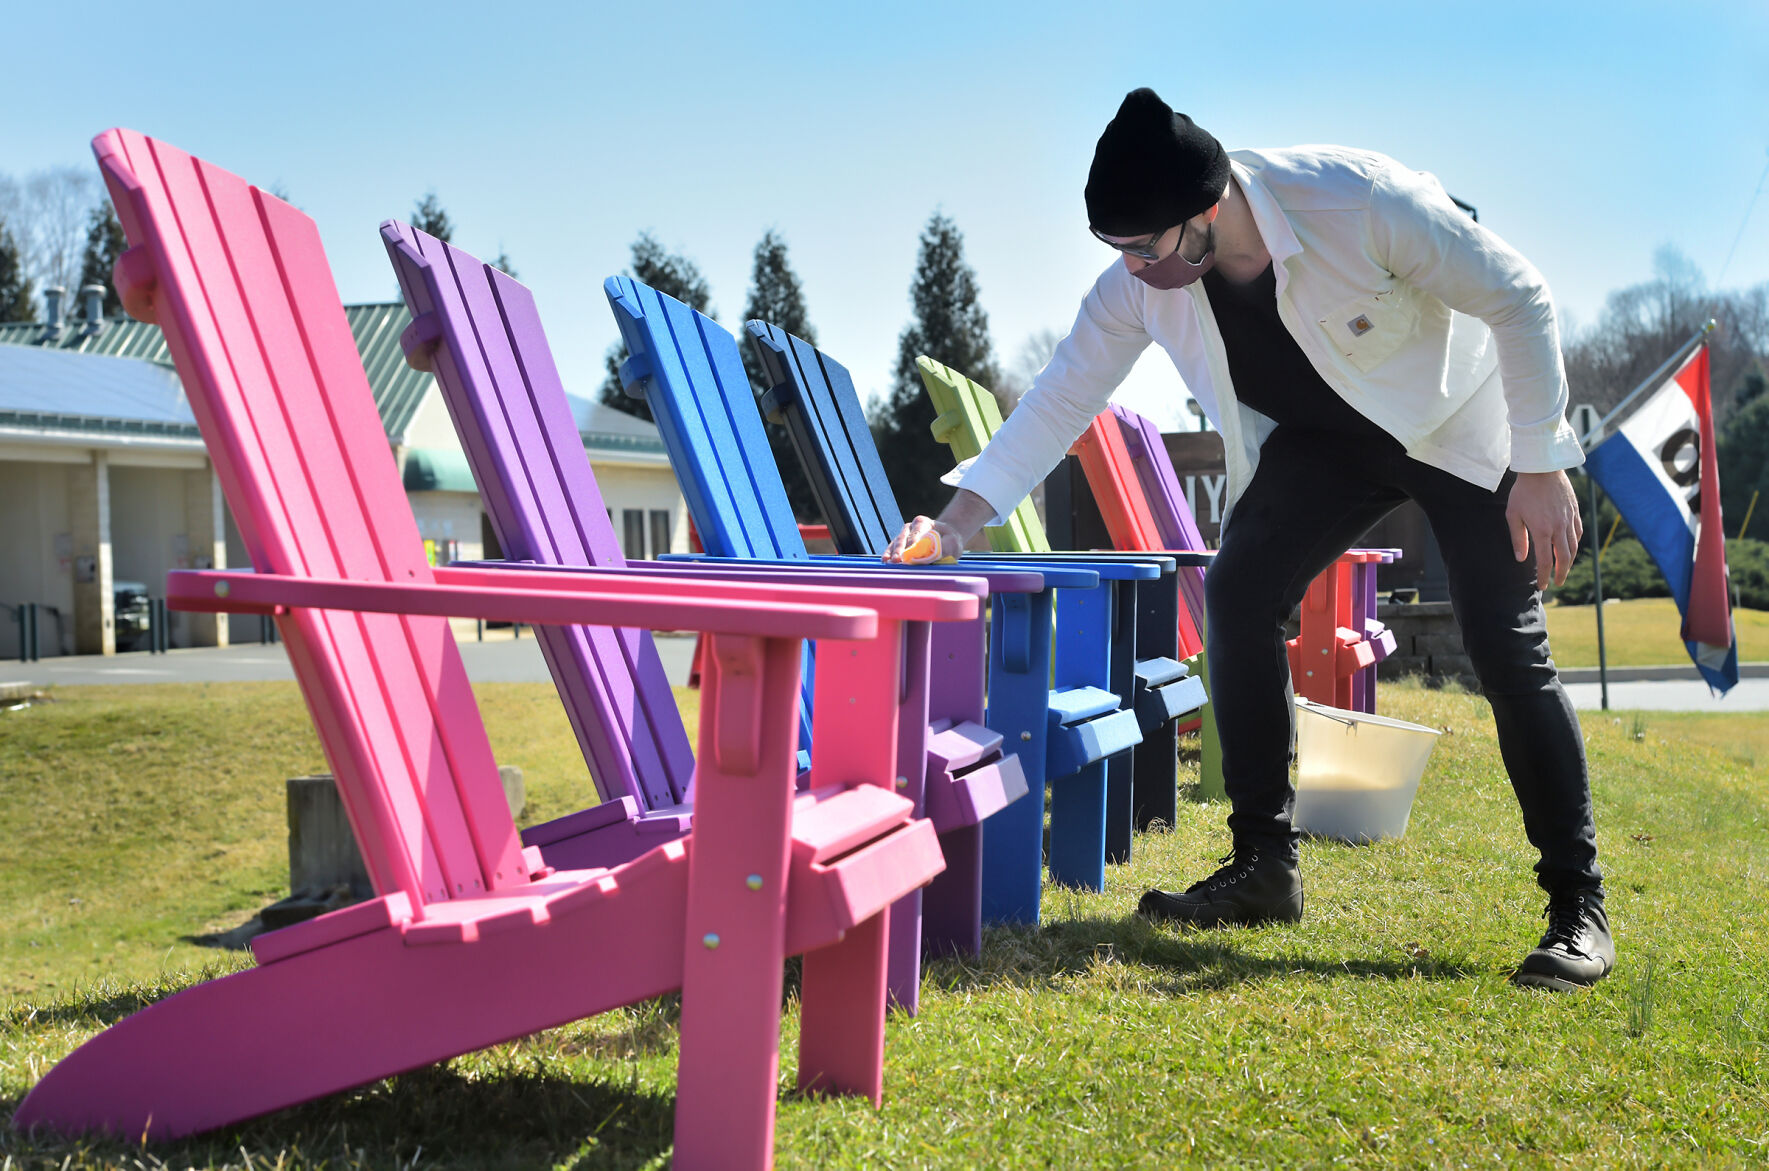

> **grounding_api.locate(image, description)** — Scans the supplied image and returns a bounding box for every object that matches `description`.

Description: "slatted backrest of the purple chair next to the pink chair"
[382,221,693,808]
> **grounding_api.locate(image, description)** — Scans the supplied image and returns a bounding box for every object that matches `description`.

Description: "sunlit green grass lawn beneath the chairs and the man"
[0,682,1769,1169]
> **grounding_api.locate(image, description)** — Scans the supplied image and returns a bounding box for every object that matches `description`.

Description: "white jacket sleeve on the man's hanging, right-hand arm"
[1369,165,1585,472]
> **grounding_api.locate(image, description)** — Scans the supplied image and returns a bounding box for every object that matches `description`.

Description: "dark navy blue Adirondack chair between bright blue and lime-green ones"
[747,320,1203,869]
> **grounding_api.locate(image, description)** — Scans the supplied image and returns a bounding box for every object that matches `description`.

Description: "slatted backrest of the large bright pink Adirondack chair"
[94,131,525,906]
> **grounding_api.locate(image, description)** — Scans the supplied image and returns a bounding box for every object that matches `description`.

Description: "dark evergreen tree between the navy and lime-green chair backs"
[872,210,1001,517]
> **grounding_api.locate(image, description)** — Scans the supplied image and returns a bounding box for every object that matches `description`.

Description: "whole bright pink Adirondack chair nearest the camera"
[14,131,976,1166]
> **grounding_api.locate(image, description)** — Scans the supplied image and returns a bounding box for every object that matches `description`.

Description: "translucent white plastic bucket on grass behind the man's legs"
[1295,697,1438,842]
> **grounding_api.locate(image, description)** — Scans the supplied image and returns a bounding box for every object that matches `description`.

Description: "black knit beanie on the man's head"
[1086,87,1229,235]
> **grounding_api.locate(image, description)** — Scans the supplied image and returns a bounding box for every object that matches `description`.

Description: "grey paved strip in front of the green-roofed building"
[0,631,693,686]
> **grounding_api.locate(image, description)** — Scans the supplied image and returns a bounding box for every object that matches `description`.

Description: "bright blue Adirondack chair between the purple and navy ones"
[605,278,1157,923]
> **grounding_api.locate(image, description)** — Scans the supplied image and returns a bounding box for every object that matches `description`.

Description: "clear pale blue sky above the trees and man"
[0,0,1769,431]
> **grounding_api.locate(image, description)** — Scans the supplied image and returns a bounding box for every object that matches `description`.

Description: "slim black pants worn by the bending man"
[1205,426,1603,892]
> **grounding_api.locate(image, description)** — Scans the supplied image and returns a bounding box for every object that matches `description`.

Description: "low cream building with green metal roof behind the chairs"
[0,285,686,660]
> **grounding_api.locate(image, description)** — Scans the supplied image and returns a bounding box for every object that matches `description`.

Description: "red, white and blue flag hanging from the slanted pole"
[1585,341,1739,692]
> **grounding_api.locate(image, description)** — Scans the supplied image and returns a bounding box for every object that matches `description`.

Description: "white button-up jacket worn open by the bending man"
[961,147,1585,520]
